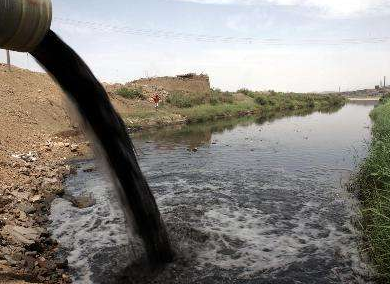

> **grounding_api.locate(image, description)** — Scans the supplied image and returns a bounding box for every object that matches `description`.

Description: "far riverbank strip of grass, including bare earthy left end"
[121,89,346,125]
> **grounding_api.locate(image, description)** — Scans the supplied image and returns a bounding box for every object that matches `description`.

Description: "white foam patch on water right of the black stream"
[170,195,368,278]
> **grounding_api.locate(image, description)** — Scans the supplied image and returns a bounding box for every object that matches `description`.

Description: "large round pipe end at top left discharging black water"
[0,0,52,52]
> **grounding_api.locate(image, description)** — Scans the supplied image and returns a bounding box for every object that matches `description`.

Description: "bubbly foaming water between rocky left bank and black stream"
[50,163,141,284]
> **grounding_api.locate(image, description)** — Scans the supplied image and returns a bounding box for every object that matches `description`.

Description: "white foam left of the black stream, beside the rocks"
[49,170,136,284]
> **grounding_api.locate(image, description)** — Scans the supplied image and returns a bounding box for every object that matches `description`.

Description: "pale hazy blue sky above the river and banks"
[0,0,390,92]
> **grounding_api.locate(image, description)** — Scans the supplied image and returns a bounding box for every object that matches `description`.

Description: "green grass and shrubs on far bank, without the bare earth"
[167,89,346,122]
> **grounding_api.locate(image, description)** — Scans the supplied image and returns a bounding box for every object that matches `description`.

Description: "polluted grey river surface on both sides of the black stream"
[50,102,375,284]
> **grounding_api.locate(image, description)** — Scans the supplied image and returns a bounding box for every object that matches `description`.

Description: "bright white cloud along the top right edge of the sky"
[175,0,390,17]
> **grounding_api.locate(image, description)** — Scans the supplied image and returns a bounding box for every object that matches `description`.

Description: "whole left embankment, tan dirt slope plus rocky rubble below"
[0,65,88,283]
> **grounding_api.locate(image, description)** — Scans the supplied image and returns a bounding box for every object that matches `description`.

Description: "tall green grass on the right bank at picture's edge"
[353,95,390,283]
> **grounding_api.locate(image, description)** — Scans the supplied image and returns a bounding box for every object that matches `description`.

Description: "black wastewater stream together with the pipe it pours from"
[0,0,173,265]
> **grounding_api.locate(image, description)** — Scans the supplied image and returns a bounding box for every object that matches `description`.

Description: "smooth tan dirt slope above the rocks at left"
[0,65,76,182]
